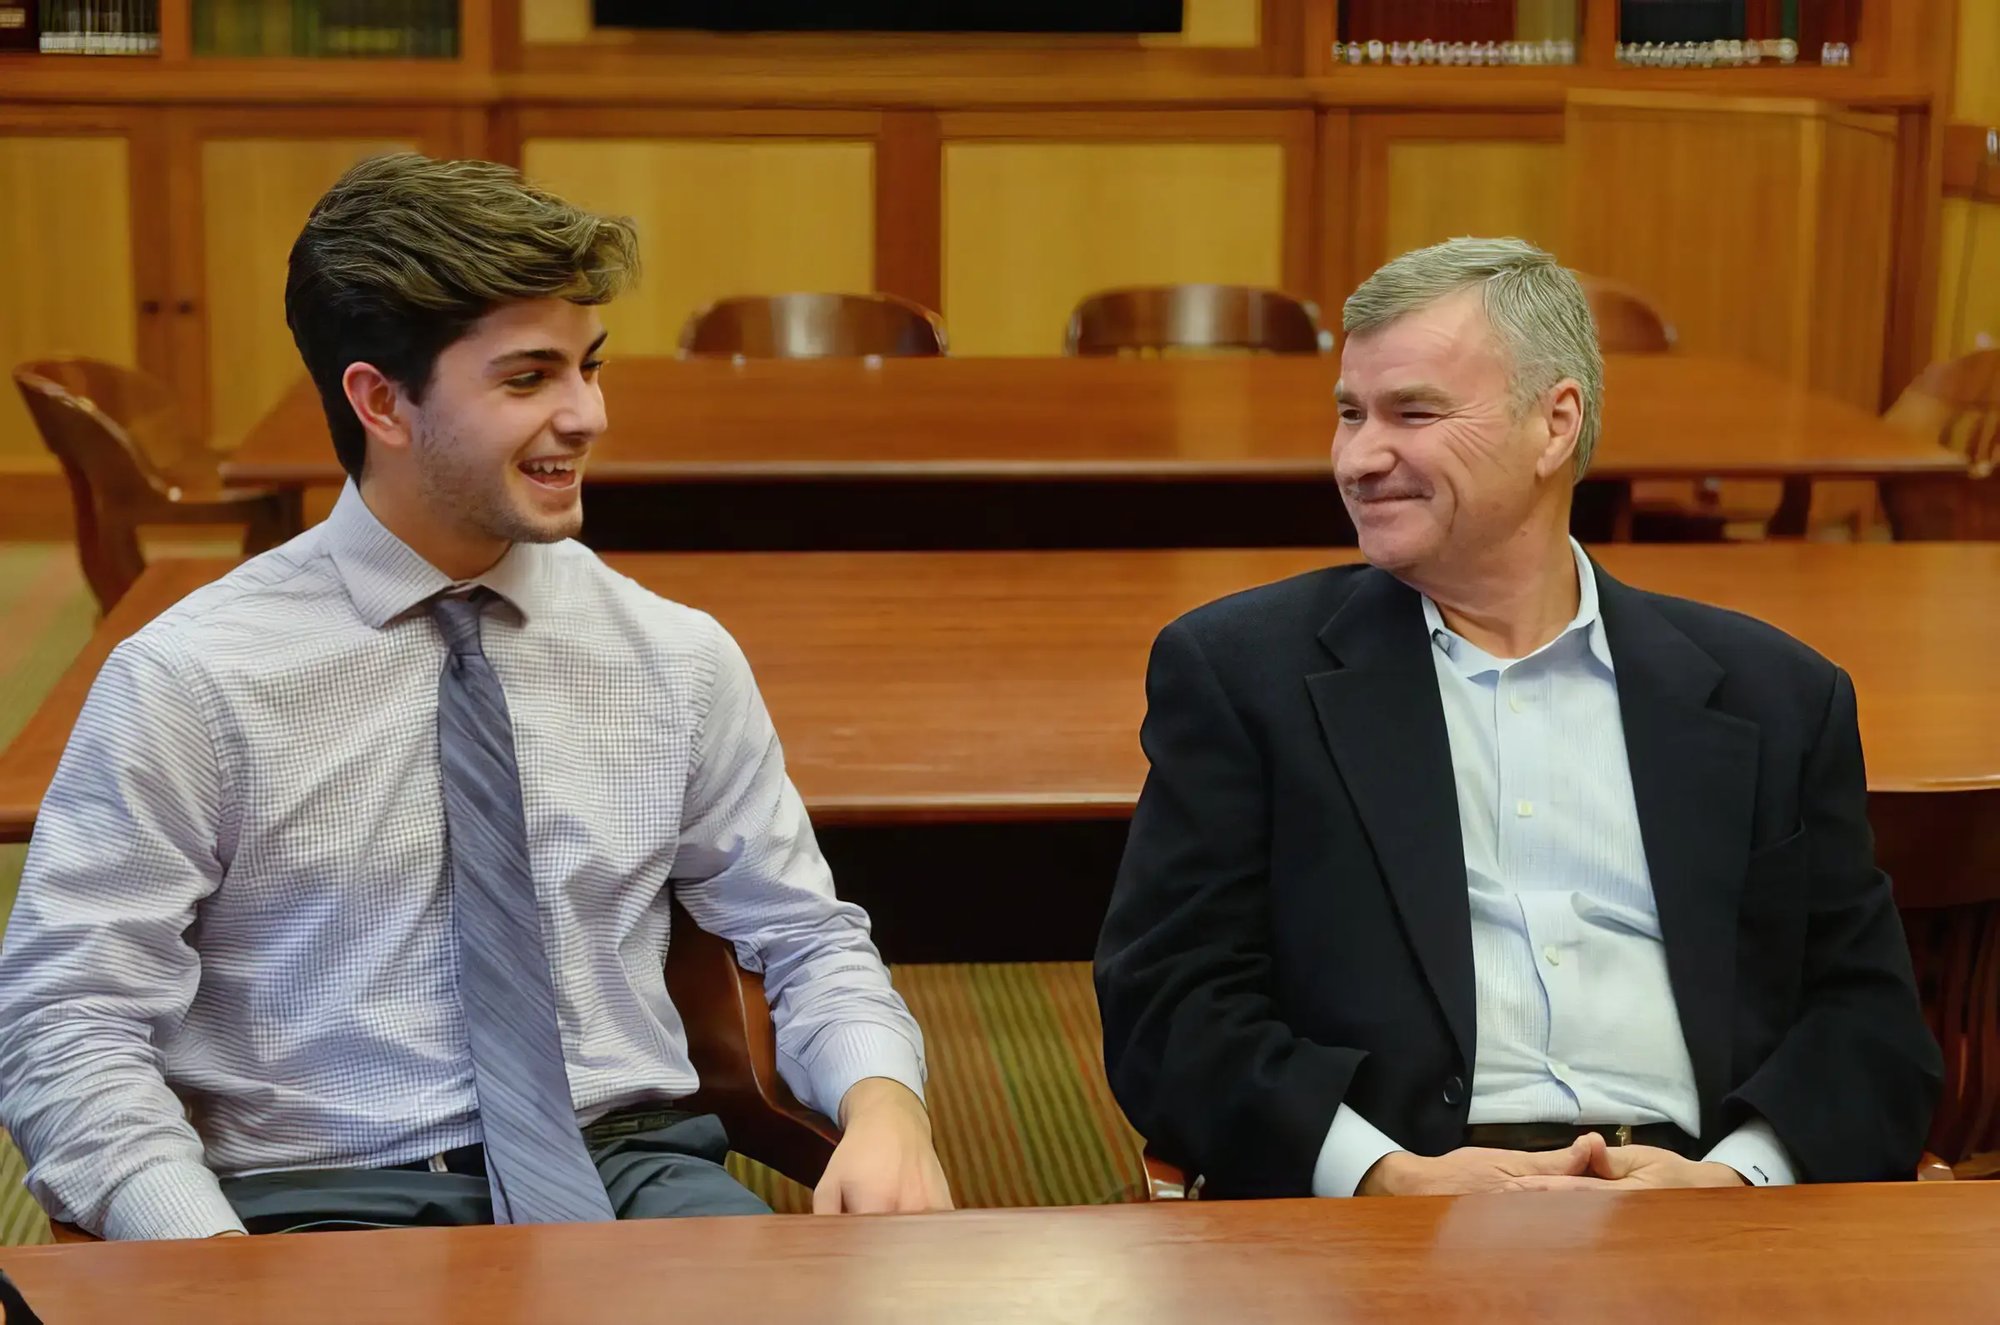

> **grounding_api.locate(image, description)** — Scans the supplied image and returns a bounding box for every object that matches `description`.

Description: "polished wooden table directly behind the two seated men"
[0,542,2000,895]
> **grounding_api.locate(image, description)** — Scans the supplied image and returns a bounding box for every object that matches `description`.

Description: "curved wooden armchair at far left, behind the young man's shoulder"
[14,358,304,610]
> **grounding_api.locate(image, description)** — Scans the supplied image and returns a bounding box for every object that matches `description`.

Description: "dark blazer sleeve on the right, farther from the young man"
[1724,671,1944,1183]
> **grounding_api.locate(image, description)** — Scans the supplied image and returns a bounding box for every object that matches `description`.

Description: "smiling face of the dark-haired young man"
[410,298,604,542]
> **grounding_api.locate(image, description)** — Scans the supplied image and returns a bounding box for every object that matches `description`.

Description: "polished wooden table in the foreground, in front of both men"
[0,1183,2000,1325]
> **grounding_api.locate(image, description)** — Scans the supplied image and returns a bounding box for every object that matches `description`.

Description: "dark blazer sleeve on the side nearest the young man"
[1096,622,1366,1197]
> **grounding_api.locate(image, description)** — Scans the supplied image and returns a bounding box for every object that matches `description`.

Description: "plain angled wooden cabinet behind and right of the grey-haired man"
[1564,92,1896,410]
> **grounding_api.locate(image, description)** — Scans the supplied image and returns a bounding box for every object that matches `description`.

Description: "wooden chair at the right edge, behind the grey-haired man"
[1882,350,2000,538]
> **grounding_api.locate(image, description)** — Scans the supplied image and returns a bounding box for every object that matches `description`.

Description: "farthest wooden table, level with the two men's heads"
[224,354,1964,550]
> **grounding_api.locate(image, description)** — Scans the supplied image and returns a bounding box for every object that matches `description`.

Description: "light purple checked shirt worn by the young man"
[0,484,924,1237]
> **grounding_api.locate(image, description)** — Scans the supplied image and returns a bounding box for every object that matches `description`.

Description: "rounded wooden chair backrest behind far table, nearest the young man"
[680,294,944,358]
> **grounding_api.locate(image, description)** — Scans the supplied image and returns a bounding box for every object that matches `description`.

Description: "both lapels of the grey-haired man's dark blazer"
[1306,562,1758,1131]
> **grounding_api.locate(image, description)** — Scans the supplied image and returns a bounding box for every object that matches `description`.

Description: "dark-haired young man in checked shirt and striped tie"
[0,154,950,1237]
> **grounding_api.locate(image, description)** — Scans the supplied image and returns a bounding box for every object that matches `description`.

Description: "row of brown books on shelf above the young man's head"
[194,0,458,60]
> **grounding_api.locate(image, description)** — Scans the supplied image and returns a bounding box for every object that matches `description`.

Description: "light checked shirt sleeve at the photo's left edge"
[0,640,242,1239]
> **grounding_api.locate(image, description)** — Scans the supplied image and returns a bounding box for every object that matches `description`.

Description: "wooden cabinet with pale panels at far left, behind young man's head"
[0,106,464,496]
